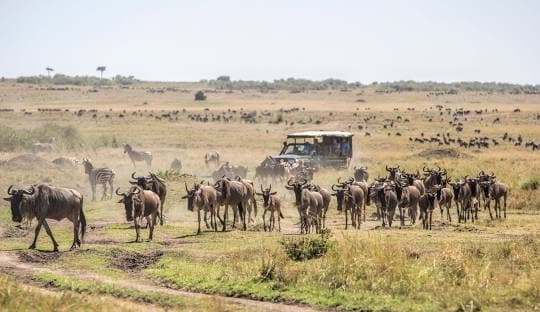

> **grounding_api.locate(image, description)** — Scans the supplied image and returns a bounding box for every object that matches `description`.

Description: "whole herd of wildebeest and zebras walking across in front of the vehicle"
[5,144,509,251]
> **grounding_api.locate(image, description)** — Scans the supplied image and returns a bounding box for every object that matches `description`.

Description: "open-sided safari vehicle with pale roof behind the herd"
[273,131,353,168]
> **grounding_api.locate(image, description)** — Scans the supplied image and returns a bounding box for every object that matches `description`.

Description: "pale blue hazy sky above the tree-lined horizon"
[0,0,540,84]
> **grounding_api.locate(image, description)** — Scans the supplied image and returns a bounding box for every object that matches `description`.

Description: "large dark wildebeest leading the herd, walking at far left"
[4,184,86,251]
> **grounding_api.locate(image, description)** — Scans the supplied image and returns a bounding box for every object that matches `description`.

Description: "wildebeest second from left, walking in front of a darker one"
[116,186,161,242]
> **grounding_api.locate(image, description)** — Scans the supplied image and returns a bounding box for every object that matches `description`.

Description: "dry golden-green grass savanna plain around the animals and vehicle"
[0,80,540,311]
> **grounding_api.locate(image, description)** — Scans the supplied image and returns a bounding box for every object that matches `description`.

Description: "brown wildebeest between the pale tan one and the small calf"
[215,178,249,232]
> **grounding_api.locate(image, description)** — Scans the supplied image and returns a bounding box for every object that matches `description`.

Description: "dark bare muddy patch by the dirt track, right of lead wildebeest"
[109,249,163,272]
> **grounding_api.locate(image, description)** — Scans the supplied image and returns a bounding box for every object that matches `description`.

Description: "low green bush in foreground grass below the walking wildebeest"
[280,230,331,261]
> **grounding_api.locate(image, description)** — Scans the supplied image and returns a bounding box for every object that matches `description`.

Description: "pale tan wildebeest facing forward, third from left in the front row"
[182,183,220,234]
